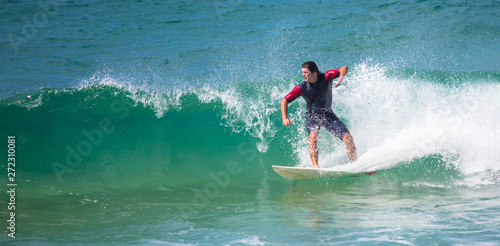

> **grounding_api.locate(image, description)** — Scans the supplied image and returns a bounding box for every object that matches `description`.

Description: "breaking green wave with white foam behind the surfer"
[0,62,500,186]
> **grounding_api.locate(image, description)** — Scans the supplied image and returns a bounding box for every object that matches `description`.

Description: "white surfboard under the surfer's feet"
[272,165,360,180]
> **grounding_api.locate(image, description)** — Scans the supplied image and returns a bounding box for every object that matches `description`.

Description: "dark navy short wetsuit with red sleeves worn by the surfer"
[285,68,349,140]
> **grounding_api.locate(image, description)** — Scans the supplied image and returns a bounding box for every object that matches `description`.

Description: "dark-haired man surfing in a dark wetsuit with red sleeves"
[281,61,358,168]
